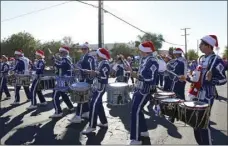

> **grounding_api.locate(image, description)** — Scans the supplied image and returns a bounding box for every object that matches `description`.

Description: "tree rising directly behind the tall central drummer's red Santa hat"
[135,33,164,50]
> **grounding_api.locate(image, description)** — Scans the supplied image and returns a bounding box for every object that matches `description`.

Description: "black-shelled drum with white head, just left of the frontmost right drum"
[160,98,181,119]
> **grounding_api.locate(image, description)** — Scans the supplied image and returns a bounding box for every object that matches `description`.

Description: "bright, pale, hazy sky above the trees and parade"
[1,1,227,53]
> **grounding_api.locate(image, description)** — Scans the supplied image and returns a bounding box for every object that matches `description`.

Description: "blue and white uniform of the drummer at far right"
[187,54,227,145]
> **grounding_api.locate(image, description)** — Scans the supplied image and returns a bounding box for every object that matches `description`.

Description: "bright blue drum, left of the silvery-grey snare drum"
[54,76,75,92]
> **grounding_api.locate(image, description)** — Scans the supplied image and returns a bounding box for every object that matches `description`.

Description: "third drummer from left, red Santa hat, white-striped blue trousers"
[27,50,47,110]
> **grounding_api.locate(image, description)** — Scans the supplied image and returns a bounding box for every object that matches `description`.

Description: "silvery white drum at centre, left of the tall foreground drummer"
[107,82,130,105]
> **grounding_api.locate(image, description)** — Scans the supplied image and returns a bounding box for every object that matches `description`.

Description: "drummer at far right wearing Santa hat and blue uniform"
[180,35,227,145]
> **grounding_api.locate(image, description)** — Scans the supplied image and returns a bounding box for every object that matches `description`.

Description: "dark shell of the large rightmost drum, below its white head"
[177,104,210,129]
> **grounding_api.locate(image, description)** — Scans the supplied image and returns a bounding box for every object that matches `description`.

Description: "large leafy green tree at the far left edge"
[1,32,39,57]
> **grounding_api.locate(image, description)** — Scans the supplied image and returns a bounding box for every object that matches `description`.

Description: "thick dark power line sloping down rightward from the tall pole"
[78,1,184,46]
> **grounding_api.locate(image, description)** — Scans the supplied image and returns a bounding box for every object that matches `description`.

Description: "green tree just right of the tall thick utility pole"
[110,43,134,58]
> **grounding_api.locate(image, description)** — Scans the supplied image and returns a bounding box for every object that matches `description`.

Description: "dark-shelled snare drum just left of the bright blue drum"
[38,76,55,90]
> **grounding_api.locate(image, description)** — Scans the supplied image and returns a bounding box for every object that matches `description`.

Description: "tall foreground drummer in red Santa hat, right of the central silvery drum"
[130,41,158,145]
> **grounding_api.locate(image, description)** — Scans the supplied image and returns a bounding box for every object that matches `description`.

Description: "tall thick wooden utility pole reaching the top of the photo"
[98,0,104,48]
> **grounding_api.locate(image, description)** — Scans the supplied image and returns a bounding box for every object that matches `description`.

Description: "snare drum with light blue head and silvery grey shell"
[69,82,91,103]
